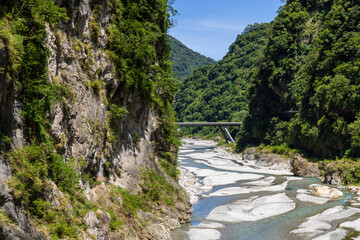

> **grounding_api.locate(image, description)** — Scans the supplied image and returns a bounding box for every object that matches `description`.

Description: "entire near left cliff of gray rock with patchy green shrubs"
[0,0,191,240]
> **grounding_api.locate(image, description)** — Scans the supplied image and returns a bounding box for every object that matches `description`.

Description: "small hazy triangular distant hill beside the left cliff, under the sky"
[168,35,216,81]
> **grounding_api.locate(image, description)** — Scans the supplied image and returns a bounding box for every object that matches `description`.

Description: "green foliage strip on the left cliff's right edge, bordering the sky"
[107,0,180,167]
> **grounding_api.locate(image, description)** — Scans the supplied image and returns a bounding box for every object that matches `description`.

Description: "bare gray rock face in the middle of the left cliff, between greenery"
[45,0,157,191]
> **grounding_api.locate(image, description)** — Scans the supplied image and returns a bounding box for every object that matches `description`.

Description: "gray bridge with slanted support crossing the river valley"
[176,122,242,143]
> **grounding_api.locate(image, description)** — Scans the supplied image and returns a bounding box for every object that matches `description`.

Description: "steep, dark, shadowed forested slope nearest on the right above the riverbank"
[238,0,360,157]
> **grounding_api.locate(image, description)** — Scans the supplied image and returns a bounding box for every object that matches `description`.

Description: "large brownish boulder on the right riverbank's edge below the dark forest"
[291,154,320,177]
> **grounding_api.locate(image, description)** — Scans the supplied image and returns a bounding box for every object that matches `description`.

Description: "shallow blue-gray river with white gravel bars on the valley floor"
[171,140,360,240]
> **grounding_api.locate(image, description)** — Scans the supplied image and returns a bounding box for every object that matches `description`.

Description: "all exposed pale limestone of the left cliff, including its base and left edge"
[0,0,190,239]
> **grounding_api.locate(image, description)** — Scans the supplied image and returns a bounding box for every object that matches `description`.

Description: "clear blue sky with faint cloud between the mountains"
[169,0,283,60]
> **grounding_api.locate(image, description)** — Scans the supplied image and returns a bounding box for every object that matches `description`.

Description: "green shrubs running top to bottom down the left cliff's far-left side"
[0,0,89,239]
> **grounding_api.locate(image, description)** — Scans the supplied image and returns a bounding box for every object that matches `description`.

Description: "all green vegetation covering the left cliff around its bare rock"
[0,0,184,239]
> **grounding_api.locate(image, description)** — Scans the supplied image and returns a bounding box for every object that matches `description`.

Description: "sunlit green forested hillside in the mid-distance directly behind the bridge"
[174,23,269,138]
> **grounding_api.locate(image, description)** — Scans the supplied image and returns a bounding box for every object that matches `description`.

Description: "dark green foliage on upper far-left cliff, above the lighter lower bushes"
[0,0,67,148]
